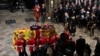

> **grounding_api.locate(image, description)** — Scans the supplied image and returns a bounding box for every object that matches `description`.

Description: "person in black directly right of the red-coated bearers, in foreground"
[55,33,67,56]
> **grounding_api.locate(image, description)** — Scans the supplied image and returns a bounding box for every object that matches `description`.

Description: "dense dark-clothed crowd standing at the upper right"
[53,0,100,36]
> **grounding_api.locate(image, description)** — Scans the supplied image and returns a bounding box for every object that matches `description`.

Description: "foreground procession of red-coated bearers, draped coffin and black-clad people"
[13,25,100,56]
